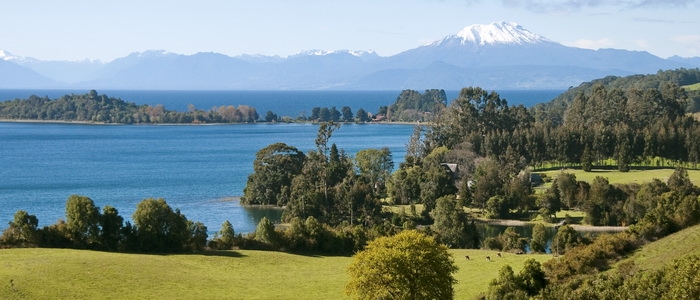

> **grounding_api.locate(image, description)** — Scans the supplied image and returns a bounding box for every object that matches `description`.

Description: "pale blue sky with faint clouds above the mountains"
[0,0,700,62]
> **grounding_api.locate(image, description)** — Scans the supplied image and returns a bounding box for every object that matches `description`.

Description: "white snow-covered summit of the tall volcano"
[430,22,552,46]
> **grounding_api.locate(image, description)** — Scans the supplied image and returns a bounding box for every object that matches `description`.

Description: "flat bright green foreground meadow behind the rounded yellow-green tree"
[0,249,551,299]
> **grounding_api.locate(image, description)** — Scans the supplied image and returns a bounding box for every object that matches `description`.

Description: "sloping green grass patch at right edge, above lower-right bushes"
[620,221,700,270]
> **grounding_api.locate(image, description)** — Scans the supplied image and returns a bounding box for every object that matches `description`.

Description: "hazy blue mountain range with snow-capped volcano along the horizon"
[0,22,700,90]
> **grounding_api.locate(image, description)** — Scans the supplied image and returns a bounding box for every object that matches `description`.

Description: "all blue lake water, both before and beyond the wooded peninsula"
[0,90,561,237]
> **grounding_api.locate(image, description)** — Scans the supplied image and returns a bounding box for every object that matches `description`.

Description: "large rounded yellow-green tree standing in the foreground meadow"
[345,230,457,299]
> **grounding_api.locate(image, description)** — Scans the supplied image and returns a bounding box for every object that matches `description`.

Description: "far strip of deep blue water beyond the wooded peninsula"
[0,90,564,118]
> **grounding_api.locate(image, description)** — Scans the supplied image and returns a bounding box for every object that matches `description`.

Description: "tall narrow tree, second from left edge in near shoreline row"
[66,195,100,247]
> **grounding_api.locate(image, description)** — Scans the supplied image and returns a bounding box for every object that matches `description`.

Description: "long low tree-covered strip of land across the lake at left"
[0,90,258,124]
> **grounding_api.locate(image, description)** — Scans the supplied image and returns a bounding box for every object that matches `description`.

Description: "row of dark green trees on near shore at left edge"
[0,195,208,253]
